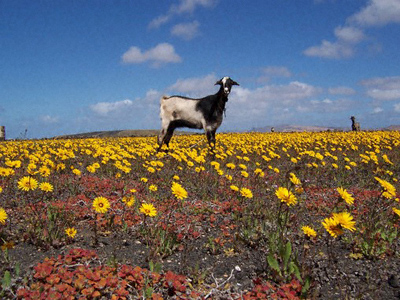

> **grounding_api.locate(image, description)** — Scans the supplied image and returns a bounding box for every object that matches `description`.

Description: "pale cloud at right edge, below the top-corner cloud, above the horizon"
[361,76,400,101]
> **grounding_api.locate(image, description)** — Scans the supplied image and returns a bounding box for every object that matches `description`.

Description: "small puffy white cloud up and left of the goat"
[122,43,182,67]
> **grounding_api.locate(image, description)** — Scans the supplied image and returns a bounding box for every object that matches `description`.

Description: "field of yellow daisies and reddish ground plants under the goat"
[0,131,400,299]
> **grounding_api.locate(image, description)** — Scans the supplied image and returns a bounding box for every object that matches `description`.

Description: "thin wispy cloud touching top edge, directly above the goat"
[149,0,217,29]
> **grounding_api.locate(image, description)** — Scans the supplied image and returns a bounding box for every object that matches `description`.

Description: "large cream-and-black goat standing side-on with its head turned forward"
[157,77,239,151]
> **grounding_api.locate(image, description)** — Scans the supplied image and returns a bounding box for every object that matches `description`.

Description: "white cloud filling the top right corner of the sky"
[349,0,400,26]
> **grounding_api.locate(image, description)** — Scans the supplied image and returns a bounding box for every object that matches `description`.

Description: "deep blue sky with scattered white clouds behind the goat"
[0,0,400,138]
